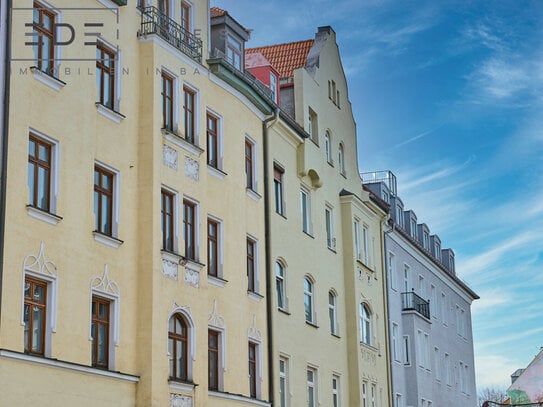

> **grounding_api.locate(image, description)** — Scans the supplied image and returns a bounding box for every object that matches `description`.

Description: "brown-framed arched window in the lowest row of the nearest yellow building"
[168,314,189,381]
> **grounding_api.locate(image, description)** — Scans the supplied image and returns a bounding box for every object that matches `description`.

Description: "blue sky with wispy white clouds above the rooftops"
[211,0,543,388]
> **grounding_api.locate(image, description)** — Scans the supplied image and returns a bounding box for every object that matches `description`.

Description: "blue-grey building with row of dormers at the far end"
[362,171,479,407]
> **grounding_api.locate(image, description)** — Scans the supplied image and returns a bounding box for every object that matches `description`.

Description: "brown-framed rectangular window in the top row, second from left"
[96,43,116,110]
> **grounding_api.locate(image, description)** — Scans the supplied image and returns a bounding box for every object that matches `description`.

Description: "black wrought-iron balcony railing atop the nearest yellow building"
[141,7,202,62]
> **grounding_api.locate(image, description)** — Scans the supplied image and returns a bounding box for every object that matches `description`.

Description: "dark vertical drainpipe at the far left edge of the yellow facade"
[0,0,12,330]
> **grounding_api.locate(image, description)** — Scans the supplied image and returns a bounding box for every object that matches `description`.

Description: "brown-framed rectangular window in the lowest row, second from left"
[91,296,110,369]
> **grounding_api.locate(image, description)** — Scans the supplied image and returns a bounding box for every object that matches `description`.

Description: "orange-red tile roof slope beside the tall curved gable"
[245,40,313,78]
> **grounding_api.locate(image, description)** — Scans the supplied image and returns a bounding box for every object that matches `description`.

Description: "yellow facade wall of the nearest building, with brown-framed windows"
[0,0,271,407]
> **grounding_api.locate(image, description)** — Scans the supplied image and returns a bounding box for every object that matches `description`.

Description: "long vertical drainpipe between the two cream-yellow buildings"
[262,108,279,405]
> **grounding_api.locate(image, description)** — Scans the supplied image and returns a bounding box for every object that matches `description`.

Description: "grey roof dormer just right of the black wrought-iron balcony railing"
[210,7,250,71]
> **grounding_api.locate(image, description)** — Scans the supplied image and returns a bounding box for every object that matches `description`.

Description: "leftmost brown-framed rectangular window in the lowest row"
[24,277,47,356]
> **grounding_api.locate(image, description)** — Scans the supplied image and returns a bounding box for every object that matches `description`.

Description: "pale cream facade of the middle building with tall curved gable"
[262,27,390,407]
